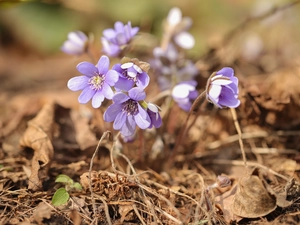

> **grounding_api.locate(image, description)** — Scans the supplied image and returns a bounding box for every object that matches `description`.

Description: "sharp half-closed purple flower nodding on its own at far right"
[206,67,240,108]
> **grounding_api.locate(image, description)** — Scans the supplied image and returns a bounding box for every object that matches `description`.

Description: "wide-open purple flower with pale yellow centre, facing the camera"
[68,56,119,108]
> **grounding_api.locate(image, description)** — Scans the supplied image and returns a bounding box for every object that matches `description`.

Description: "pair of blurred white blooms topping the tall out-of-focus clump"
[165,7,195,49]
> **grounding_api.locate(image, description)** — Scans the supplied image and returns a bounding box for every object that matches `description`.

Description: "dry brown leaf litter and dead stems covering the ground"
[0,1,300,224]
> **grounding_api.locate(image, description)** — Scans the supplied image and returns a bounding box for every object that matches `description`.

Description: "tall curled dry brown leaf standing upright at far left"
[20,102,55,191]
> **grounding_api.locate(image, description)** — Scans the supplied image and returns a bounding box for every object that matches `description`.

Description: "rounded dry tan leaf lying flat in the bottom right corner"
[231,175,276,218]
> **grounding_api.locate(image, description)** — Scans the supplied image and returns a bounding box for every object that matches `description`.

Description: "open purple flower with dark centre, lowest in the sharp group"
[103,87,151,137]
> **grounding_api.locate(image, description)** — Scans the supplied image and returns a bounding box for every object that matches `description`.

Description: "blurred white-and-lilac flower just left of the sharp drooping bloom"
[172,80,198,111]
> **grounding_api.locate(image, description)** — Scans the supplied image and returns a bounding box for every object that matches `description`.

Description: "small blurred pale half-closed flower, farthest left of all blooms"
[60,31,89,55]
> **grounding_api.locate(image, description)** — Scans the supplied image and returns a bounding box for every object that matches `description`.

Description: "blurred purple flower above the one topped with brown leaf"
[101,21,139,56]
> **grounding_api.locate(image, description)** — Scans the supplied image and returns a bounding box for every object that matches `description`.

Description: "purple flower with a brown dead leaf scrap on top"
[112,57,150,91]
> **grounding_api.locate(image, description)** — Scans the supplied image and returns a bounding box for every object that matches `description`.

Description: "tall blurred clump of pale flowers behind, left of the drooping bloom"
[151,8,199,111]
